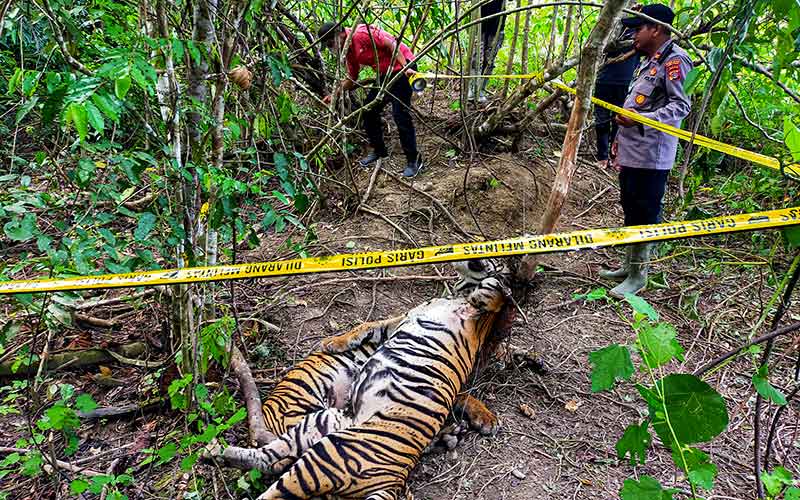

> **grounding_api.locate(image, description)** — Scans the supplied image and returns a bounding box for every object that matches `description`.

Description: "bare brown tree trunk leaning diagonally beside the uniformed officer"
[517,0,627,281]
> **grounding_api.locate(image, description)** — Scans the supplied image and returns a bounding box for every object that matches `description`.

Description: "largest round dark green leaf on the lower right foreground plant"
[640,374,728,446]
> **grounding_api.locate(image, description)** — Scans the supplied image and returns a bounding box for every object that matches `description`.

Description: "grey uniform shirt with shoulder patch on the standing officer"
[617,40,692,170]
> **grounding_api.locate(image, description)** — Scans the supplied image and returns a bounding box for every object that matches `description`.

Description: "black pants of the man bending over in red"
[364,65,419,161]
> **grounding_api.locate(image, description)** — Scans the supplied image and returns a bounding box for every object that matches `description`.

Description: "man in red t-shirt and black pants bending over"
[317,22,423,177]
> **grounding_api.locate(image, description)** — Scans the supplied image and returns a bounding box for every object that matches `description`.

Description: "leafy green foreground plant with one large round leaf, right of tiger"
[589,295,728,500]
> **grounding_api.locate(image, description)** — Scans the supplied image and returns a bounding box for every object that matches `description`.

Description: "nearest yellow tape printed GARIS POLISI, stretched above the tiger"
[0,207,800,295]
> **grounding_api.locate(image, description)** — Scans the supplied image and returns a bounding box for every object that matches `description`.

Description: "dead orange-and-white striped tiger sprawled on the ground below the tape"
[216,261,507,500]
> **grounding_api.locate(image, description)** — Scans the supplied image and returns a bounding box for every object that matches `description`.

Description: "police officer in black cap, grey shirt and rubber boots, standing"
[600,4,692,298]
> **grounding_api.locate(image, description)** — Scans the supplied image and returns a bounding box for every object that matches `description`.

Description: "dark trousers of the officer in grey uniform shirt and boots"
[619,167,669,226]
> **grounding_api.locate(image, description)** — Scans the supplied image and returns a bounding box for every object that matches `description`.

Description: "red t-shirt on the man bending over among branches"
[345,24,414,80]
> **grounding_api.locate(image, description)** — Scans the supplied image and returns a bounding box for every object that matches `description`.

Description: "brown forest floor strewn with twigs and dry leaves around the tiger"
[0,88,800,500]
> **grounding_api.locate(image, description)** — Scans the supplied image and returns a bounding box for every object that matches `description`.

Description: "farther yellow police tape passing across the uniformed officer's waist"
[409,72,800,179]
